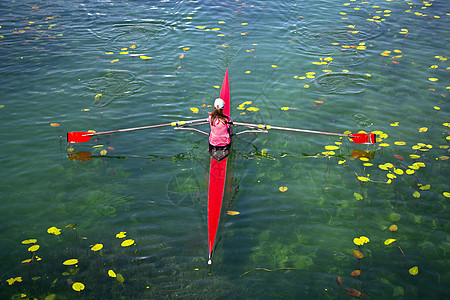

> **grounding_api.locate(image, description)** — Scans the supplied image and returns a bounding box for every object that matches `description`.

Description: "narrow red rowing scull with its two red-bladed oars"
[67,69,376,265]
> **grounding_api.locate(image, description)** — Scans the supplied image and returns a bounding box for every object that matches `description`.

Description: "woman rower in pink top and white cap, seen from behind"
[208,98,233,161]
